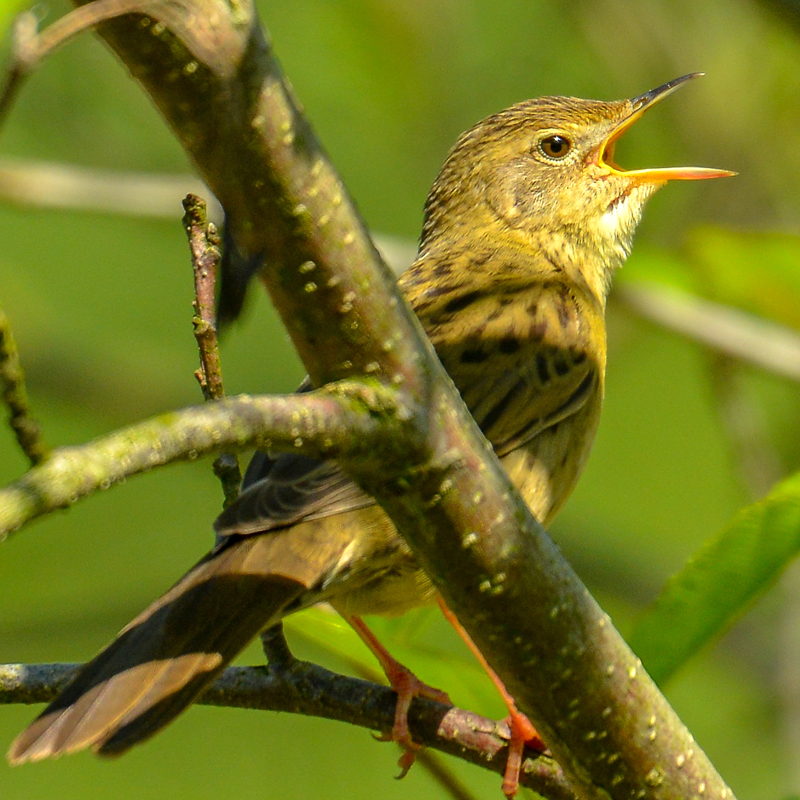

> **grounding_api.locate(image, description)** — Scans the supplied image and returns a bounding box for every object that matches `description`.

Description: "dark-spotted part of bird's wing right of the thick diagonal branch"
[412,266,605,456]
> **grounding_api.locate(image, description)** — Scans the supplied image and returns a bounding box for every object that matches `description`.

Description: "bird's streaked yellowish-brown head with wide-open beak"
[422,73,734,292]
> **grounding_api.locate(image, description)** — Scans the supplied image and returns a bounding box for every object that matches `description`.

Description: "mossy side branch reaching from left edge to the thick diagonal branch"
[0,382,407,540]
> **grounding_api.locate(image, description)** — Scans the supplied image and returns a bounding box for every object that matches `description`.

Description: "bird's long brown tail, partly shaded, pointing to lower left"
[8,529,338,764]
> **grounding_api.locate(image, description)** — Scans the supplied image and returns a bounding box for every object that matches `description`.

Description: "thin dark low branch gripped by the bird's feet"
[0,661,575,800]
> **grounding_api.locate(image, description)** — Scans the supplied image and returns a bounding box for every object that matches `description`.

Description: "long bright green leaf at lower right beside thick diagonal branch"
[628,473,800,683]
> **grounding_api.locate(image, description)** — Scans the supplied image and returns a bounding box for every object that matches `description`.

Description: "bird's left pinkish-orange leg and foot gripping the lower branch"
[347,616,452,778]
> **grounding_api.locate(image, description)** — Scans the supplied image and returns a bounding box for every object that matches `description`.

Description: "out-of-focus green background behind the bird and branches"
[0,0,800,800]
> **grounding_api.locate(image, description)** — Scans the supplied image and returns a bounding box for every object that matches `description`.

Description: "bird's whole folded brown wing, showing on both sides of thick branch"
[215,260,605,537]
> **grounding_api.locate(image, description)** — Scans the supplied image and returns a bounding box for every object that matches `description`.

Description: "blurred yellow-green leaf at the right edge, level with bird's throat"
[688,227,800,328]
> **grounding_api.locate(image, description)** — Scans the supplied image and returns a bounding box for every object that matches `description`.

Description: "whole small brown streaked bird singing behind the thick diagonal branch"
[9,75,733,789]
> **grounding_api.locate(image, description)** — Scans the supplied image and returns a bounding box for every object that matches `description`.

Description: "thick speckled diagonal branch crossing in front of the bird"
[78,0,732,800]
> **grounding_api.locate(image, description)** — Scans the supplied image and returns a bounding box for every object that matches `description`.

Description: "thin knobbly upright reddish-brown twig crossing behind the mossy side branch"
[183,194,242,506]
